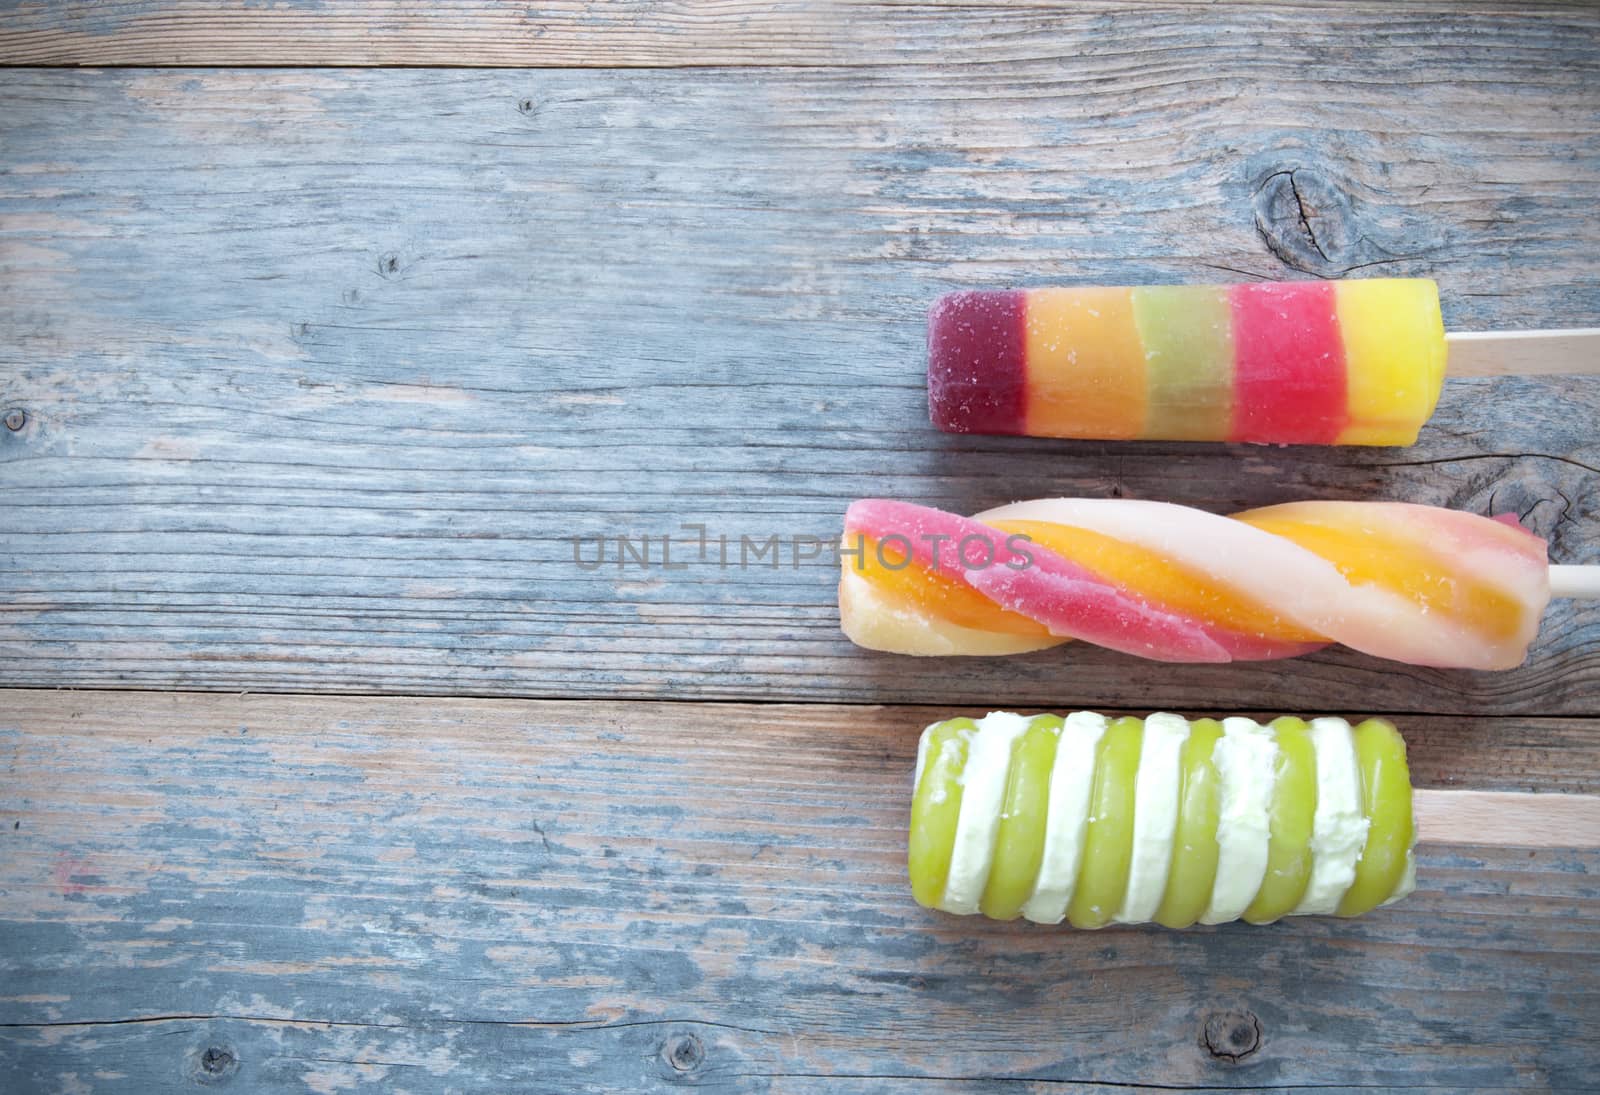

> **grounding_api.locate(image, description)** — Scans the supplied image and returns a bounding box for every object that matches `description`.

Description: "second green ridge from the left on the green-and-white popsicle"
[979,716,1062,921]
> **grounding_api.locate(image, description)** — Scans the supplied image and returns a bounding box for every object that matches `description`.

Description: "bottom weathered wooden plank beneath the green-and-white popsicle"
[0,692,1600,1093]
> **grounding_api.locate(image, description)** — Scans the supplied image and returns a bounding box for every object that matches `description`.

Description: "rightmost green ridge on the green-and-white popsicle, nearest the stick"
[1339,719,1411,916]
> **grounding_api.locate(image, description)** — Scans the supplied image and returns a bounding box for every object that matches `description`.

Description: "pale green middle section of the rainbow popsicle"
[1133,285,1234,440]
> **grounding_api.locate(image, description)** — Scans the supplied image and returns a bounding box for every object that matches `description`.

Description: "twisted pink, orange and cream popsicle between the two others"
[838,498,1550,669]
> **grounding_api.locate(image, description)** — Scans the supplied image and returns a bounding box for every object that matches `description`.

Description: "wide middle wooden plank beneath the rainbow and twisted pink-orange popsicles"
[0,66,1600,716]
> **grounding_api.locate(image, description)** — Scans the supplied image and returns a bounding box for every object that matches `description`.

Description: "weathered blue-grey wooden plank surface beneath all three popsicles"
[0,0,1600,1095]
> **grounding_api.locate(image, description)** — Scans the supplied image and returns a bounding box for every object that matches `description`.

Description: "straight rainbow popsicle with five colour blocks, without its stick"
[928,279,1445,445]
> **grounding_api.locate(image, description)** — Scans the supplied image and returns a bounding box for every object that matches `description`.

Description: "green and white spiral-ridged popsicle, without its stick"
[909,711,1416,929]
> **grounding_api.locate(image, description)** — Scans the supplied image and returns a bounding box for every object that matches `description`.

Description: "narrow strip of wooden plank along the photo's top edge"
[0,0,1594,68]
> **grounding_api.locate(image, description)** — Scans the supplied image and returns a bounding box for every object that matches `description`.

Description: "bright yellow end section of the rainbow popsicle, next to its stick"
[1333,279,1445,445]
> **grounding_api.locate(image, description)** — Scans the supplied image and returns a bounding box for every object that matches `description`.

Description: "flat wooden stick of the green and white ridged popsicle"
[1411,789,1600,848]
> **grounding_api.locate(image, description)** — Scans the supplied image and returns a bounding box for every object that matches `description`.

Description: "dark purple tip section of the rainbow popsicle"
[928,290,1027,434]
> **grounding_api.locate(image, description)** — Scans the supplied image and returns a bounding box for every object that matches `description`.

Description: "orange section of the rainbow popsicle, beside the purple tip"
[1022,288,1149,440]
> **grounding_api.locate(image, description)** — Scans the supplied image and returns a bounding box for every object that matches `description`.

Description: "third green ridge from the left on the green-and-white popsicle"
[1067,719,1144,929]
